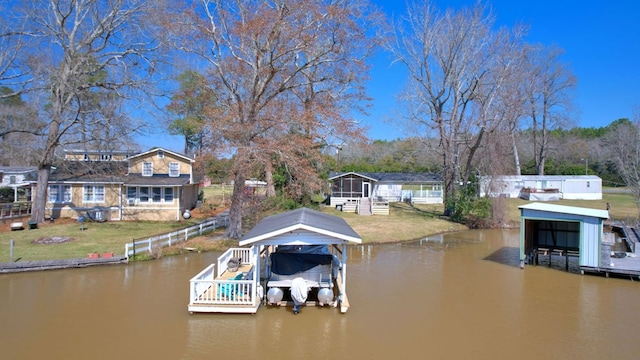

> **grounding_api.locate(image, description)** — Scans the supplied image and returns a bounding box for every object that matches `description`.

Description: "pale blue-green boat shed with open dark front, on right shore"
[519,202,609,268]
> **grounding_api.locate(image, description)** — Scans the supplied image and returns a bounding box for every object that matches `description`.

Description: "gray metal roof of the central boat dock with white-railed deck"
[240,208,362,246]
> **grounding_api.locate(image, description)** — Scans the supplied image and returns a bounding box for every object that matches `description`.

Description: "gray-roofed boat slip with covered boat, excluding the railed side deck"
[240,208,362,313]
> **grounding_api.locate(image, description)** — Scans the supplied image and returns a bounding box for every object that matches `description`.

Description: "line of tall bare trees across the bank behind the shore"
[0,0,640,238]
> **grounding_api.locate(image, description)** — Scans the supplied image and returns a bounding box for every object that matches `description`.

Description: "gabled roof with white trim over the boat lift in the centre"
[239,208,362,246]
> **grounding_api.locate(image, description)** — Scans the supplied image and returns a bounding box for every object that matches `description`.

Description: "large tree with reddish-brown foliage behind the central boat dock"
[167,0,380,238]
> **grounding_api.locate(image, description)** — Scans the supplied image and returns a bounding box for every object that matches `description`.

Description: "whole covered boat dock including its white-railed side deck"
[188,208,362,313]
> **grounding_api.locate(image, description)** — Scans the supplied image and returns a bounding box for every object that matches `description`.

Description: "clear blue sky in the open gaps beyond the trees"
[139,0,640,151]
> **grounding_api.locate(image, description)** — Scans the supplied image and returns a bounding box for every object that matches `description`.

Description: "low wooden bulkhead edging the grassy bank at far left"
[0,256,128,273]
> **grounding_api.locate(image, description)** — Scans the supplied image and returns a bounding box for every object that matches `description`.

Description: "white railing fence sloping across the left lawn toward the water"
[124,216,229,258]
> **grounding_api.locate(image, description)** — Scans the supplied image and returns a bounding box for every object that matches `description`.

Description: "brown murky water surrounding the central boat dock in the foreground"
[0,230,640,360]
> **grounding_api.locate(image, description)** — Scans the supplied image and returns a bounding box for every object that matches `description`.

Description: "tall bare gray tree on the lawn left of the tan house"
[14,0,155,222]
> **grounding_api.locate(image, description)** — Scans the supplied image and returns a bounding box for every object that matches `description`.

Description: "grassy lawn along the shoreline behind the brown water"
[0,193,638,262]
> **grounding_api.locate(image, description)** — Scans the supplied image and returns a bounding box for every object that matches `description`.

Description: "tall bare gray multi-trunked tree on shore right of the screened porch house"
[387,1,521,211]
